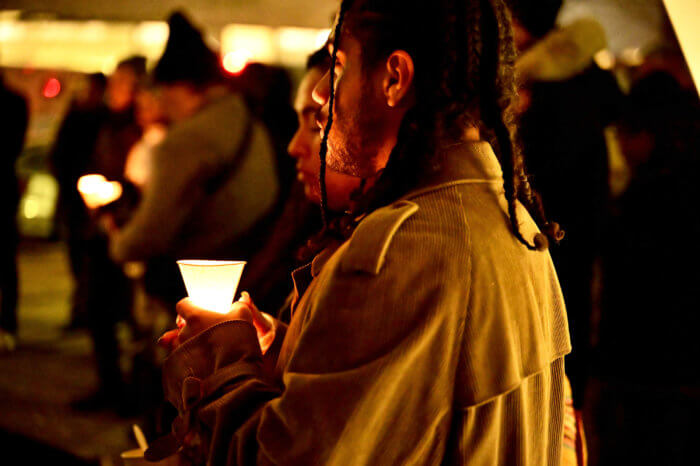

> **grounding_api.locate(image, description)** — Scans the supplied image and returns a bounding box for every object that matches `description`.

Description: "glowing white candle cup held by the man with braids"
[177,260,246,314]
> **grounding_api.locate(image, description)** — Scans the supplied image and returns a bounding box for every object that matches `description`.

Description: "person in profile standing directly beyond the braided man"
[240,47,360,318]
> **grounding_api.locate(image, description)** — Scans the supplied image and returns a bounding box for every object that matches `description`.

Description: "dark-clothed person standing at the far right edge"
[595,71,700,466]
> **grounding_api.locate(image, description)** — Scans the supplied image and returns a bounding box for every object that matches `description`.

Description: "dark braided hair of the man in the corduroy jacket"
[320,0,562,249]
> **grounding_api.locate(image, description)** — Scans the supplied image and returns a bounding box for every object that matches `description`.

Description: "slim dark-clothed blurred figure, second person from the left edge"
[49,73,107,329]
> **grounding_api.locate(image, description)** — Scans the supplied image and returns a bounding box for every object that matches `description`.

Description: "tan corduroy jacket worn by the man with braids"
[159,143,570,465]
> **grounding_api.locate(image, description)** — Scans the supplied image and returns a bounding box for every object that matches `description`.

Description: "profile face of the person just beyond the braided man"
[287,68,360,211]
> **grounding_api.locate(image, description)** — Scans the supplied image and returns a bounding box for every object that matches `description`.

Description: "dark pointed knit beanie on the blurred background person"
[153,12,222,86]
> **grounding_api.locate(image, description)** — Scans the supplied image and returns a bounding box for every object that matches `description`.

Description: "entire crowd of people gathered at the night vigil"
[0,0,700,464]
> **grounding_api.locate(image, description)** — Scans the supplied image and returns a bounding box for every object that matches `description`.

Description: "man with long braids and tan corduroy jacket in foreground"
[152,0,570,465]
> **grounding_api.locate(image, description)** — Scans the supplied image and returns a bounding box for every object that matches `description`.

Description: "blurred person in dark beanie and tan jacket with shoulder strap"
[110,13,278,310]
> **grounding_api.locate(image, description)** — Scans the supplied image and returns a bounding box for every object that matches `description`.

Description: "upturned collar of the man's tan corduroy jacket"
[403,142,503,199]
